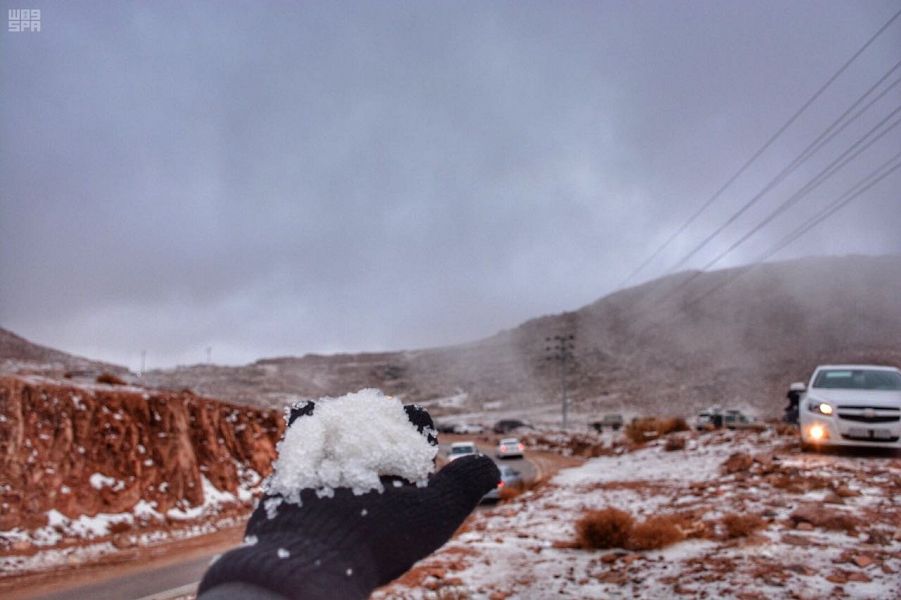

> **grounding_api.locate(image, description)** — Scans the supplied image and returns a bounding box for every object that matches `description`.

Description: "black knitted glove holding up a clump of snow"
[199,402,500,600]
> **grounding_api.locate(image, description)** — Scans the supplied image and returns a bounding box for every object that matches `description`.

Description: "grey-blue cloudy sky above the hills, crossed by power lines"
[0,0,901,368]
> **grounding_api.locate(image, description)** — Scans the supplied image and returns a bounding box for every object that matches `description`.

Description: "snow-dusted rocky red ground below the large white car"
[374,431,901,600]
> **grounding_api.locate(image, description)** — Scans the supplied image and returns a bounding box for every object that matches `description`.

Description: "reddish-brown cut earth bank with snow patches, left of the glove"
[0,376,284,543]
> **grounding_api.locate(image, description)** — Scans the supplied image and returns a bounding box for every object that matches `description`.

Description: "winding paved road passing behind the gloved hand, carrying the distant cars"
[21,436,541,600]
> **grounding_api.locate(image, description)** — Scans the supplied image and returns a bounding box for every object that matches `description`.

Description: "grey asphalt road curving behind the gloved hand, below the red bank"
[31,443,538,600]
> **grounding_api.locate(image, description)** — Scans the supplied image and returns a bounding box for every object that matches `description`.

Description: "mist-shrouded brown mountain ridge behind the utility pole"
[146,256,901,420]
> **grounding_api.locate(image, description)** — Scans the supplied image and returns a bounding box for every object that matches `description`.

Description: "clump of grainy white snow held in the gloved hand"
[267,389,438,503]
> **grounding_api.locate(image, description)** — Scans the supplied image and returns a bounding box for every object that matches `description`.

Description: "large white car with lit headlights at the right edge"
[793,365,901,449]
